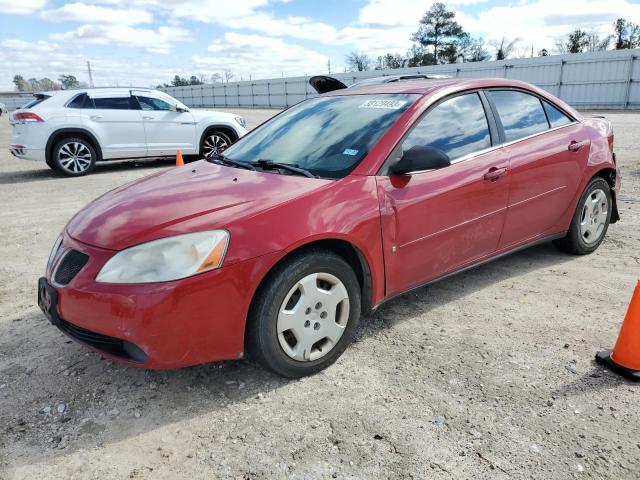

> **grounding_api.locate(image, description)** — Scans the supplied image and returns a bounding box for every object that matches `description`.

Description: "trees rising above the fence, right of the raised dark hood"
[346,2,640,71]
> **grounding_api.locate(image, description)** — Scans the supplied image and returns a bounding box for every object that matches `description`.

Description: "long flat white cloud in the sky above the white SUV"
[50,24,192,53]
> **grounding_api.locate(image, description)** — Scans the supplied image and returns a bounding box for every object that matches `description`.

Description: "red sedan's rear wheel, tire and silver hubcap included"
[553,177,613,255]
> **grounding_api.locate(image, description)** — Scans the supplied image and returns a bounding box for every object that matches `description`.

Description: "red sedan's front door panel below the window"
[377,149,509,295]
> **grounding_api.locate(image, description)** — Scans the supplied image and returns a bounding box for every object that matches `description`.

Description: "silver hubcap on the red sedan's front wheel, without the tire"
[277,273,349,362]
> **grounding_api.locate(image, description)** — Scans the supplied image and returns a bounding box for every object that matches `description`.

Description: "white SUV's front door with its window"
[133,92,199,156]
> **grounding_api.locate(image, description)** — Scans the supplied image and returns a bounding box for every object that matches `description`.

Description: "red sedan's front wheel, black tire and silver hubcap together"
[245,250,361,378]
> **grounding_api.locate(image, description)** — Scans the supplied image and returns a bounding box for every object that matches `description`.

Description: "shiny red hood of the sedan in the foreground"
[66,160,333,250]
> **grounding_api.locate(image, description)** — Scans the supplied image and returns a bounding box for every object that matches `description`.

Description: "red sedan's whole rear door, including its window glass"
[487,90,590,248]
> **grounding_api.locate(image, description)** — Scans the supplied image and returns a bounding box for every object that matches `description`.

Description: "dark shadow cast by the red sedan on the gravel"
[0,244,580,466]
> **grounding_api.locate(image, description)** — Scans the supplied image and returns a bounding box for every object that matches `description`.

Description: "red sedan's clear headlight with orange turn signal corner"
[96,230,229,283]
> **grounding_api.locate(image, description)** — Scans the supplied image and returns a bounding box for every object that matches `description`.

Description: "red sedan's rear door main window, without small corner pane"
[487,90,549,142]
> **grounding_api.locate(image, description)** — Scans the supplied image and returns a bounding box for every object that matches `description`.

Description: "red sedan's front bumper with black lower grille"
[41,234,279,369]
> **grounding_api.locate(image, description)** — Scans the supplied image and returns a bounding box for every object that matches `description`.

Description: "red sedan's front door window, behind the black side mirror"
[402,93,491,160]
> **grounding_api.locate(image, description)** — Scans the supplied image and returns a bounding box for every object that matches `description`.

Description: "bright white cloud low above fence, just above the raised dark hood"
[192,32,327,80]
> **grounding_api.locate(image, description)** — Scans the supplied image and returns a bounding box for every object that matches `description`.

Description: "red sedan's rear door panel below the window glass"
[500,123,590,248]
